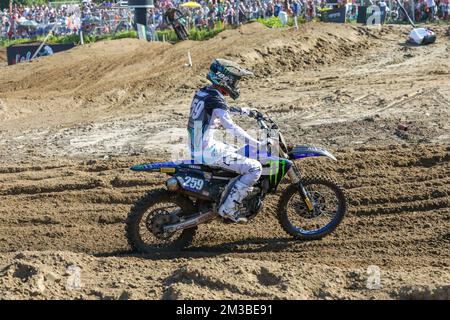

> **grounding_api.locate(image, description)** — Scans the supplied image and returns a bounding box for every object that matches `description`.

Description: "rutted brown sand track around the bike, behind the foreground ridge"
[0,147,450,258]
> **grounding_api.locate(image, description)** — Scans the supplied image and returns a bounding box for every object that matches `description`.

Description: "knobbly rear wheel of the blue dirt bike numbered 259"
[125,189,197,253]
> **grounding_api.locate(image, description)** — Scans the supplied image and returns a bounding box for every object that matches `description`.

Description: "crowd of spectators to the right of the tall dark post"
[150,0,450,28]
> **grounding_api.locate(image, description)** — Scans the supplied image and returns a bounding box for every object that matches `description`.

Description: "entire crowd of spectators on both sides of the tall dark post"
[0,0,450,38]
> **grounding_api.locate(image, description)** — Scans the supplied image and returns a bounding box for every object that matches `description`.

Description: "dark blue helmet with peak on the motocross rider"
[207,59,253,100]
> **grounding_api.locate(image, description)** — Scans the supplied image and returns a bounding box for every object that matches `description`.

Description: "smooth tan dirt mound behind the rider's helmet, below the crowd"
[0,23,386,126]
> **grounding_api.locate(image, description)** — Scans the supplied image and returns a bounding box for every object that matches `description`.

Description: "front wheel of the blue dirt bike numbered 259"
[277,176,347,240]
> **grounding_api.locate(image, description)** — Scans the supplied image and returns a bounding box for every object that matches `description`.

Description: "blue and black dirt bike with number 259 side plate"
[126,114,347,253]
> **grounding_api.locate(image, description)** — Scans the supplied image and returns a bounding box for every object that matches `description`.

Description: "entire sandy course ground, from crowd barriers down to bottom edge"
[0,24,450,299]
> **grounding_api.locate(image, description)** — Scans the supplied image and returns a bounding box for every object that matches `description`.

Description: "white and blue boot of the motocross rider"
[219,180,253,223]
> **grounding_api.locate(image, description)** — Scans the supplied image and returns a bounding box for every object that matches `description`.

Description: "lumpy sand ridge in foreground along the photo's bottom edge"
[0,251,450,300]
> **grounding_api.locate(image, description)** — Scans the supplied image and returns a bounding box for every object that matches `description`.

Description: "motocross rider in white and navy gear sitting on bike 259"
[188,59,268,223]
